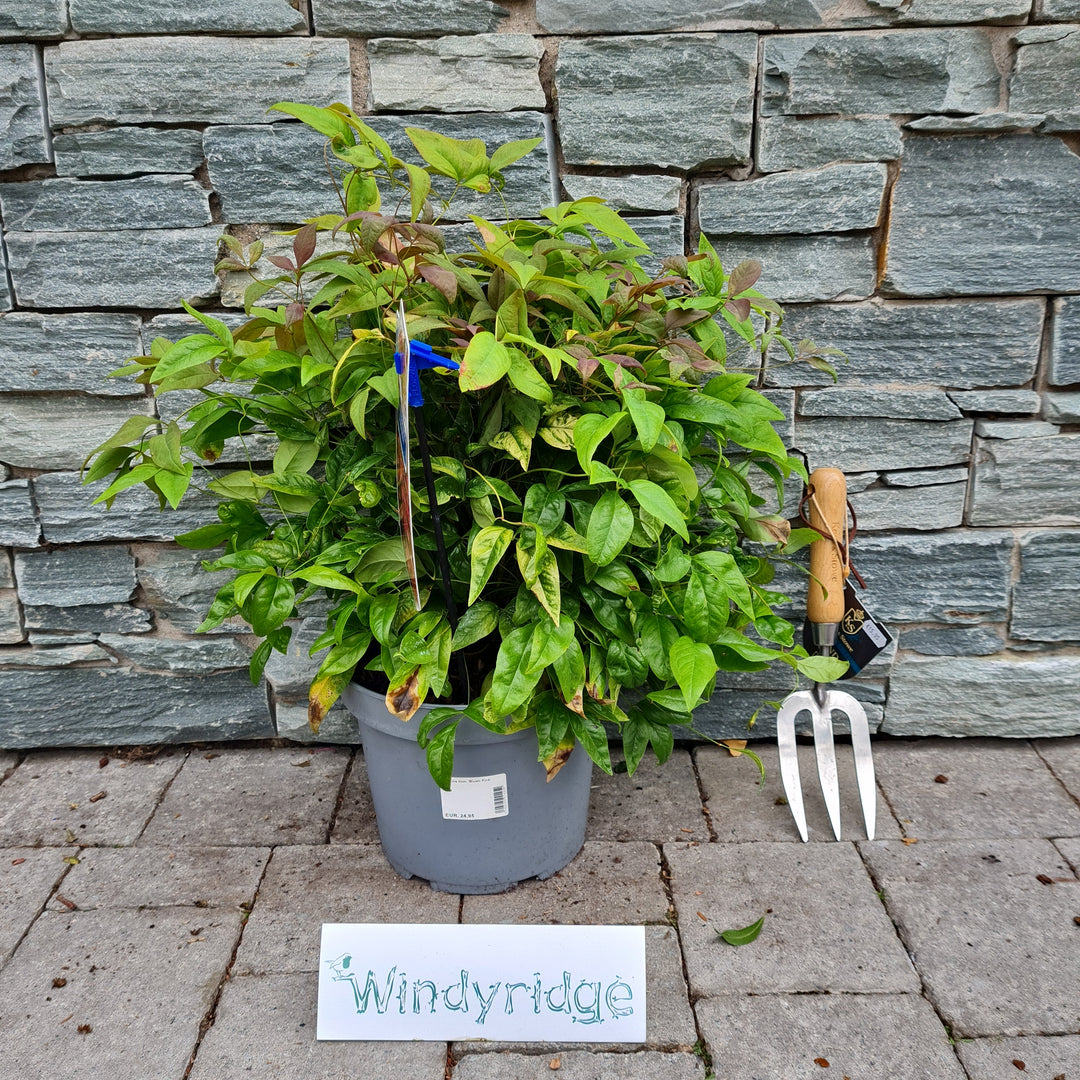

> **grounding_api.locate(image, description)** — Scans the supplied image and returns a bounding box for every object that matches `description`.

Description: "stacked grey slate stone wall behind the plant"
[0,0,1080,747]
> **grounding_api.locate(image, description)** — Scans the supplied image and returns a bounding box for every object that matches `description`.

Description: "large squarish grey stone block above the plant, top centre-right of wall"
[555,33,757,170]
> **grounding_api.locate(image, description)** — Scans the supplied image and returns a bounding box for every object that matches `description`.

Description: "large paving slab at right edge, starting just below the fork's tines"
[862,839,1080,1037]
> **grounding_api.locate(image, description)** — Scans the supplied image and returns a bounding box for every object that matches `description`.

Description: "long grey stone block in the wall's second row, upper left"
[45,37,351,126]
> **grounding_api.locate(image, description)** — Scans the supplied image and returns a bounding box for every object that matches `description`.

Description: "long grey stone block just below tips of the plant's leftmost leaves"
[35,472,217,544]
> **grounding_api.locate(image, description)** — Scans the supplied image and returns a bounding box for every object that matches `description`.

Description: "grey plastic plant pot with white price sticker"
[342,683,593,894]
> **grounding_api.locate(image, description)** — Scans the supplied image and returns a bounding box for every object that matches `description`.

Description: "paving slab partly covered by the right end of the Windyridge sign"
[450,927,698,1057]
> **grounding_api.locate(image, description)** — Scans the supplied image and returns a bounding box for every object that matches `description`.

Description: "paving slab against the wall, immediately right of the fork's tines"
[874,739,1080,840]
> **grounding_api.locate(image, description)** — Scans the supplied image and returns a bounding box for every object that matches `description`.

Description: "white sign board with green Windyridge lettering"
[318,922,645,1042]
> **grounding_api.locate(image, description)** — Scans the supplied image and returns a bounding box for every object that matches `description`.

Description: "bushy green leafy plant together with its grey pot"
[85,104,832,891]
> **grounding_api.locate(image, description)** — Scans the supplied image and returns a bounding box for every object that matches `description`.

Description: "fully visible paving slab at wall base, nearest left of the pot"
[140,746,350,847]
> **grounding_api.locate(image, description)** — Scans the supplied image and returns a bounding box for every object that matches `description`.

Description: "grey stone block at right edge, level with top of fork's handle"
[968,435,1080,525]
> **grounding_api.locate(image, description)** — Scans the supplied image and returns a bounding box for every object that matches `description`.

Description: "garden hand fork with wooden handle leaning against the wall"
[777,469,877,841]
